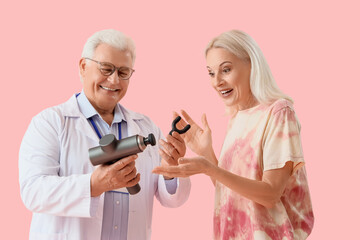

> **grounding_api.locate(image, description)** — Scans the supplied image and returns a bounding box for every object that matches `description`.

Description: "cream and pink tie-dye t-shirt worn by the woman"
[214,99,314,240]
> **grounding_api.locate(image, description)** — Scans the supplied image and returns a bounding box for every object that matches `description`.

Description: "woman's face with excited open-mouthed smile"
[206,48,252,109]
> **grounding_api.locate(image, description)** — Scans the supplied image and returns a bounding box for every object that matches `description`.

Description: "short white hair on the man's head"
[81,29,135,65]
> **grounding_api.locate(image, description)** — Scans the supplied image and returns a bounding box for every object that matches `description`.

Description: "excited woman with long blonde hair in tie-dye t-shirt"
[153,30,314,239]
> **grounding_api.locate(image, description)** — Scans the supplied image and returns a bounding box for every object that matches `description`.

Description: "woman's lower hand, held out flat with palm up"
[152,156,217,178]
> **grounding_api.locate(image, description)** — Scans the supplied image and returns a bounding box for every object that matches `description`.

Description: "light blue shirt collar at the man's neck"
[76,90,125,123]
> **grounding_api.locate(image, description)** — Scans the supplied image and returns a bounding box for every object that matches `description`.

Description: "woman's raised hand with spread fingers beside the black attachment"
[174,110,213,157]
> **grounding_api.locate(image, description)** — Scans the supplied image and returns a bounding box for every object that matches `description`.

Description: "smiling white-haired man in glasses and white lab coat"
[19,30,190,240]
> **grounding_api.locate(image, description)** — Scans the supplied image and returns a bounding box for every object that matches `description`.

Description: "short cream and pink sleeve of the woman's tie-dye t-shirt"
[263,106,304,174]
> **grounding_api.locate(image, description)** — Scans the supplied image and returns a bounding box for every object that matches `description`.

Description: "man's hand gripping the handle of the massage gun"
[90,155,140,197]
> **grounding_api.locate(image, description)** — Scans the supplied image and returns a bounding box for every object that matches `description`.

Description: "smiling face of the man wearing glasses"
[80,43,132,114]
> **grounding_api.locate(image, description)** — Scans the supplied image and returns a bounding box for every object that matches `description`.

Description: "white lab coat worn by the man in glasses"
[19,95,190,240]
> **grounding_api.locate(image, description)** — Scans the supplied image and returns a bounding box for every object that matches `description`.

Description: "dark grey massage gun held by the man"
[89,133,156,195]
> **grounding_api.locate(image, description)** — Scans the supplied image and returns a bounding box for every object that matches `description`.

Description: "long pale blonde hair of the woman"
[205,30,293,103]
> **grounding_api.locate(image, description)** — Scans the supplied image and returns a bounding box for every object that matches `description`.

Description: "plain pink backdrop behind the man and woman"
[0,0,360,240]
